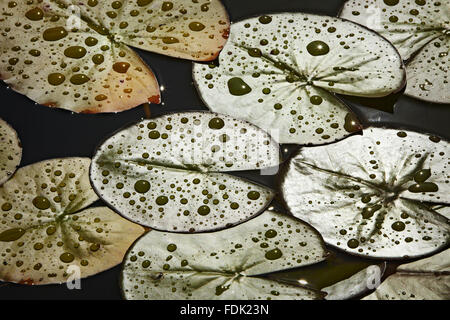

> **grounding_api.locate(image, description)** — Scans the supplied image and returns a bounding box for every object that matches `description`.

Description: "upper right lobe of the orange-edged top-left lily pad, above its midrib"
[72,0,230,61]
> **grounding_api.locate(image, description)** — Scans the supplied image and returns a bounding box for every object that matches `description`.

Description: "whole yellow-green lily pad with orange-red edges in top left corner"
[0,0,229,113]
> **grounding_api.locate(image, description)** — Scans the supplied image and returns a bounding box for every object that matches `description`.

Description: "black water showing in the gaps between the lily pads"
[0,0,450,300]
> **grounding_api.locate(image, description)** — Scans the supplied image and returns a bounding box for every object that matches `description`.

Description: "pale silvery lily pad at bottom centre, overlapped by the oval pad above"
[121,211,327,300]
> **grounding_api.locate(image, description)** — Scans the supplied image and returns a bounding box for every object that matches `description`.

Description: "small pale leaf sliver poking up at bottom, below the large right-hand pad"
[322,263,386,300]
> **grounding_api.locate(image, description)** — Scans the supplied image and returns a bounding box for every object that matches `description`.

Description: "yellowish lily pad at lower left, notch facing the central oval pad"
[0,158,144,284]
